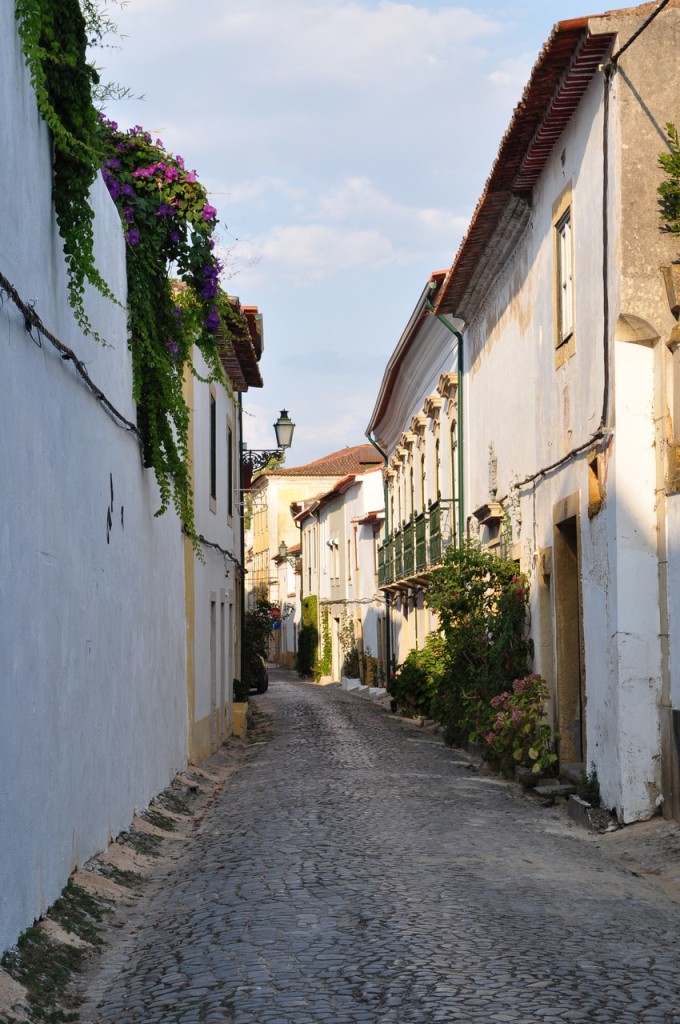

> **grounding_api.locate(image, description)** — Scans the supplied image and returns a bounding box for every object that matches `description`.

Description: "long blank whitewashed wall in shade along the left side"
[0,3,186,949]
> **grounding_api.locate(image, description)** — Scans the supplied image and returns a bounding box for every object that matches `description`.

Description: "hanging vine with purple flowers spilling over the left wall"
[100,118,242,537]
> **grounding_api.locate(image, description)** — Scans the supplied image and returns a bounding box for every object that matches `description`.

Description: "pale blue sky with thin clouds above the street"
[96,0,606,465]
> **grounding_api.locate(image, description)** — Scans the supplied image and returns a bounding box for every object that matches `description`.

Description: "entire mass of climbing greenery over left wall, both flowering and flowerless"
[14,0,248,543]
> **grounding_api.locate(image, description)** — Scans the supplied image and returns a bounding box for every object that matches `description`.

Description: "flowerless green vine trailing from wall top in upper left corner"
[14,0,114,337]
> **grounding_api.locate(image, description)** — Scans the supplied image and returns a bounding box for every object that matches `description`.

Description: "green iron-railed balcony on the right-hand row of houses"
[378,499,456,590]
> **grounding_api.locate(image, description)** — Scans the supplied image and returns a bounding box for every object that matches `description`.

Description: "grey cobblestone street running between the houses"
[80,672,680,1024]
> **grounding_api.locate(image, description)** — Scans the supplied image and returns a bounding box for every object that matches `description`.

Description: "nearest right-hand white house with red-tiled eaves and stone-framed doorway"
[370,0,680,821]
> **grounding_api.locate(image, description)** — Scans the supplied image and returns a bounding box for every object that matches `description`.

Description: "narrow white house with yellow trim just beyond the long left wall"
[184,307,263,762]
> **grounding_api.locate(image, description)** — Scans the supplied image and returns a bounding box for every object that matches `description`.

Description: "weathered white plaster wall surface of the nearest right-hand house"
[458,49,661,820]
